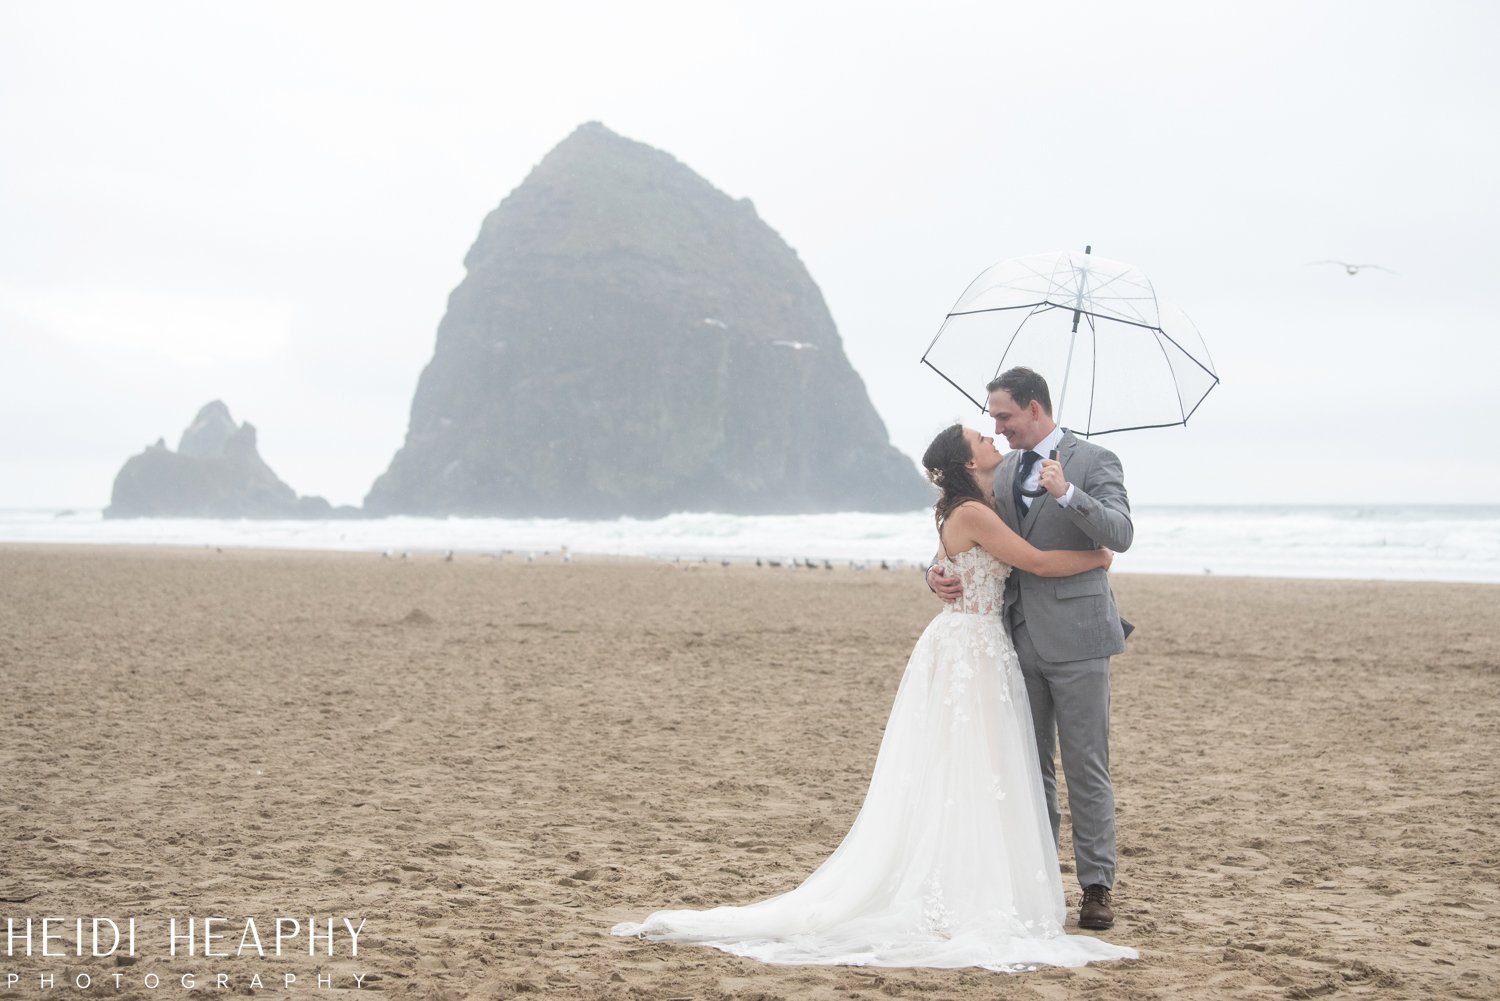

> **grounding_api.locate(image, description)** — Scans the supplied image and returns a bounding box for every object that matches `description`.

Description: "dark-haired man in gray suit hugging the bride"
[927,368,1134,929]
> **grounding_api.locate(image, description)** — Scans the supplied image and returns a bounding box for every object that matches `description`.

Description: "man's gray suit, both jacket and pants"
[995,431,1134,887]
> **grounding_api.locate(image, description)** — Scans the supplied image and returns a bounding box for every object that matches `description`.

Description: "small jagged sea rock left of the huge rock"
[104,399,356,518]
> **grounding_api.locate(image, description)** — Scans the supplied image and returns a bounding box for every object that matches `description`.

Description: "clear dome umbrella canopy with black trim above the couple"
[923,251,1220,437]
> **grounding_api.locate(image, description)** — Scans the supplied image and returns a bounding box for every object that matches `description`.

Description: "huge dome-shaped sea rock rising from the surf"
[365,123,932,518]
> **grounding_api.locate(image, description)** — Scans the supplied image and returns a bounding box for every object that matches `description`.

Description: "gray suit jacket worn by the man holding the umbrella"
[995,431,1136,663]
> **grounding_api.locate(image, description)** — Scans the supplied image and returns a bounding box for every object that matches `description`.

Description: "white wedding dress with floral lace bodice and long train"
[612,546,1137,972]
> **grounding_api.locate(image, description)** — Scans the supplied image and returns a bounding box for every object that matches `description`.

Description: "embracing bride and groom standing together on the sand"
[614,369,1137,972]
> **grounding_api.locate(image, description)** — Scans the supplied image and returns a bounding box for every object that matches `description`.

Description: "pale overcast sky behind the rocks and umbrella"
[0,0,1500,507]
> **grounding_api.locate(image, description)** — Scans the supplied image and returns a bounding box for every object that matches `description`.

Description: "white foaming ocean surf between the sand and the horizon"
[11,504,1500,584]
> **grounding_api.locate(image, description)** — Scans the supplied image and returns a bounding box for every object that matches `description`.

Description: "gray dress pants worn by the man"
[1011,615,1115,887]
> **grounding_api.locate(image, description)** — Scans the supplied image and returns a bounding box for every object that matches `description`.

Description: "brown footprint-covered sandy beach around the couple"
[0,545,1500,1001]
